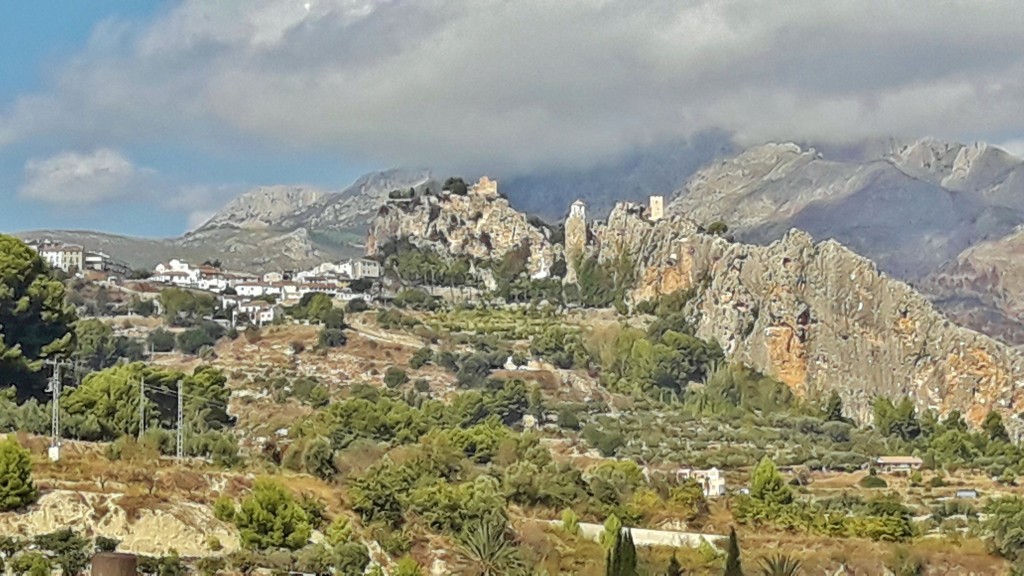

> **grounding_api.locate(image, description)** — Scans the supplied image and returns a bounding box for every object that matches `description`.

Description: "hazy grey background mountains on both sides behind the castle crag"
[14,138,1024,344]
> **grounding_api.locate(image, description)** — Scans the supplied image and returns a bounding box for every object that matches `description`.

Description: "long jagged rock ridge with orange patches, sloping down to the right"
[594,204,1024,422]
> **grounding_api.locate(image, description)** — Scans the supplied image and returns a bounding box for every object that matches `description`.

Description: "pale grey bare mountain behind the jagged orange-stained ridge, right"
[668,139,1024,343]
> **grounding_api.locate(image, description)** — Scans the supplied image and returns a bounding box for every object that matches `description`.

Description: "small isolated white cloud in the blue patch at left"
[19,149,152,206]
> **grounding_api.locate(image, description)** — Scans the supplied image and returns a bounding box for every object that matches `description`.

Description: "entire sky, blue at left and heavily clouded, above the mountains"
[0,0,1024,237]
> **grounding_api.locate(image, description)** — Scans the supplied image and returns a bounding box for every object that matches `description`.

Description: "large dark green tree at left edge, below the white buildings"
[0,235,75,398]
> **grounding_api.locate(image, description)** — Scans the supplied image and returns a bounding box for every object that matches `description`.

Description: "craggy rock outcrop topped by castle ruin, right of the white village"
[367,178,561,275]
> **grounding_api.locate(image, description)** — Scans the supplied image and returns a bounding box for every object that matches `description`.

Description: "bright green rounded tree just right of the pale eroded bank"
[234,478,311,550]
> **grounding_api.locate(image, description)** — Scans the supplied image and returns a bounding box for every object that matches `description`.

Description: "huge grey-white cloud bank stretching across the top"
[0,0,1024,169]
